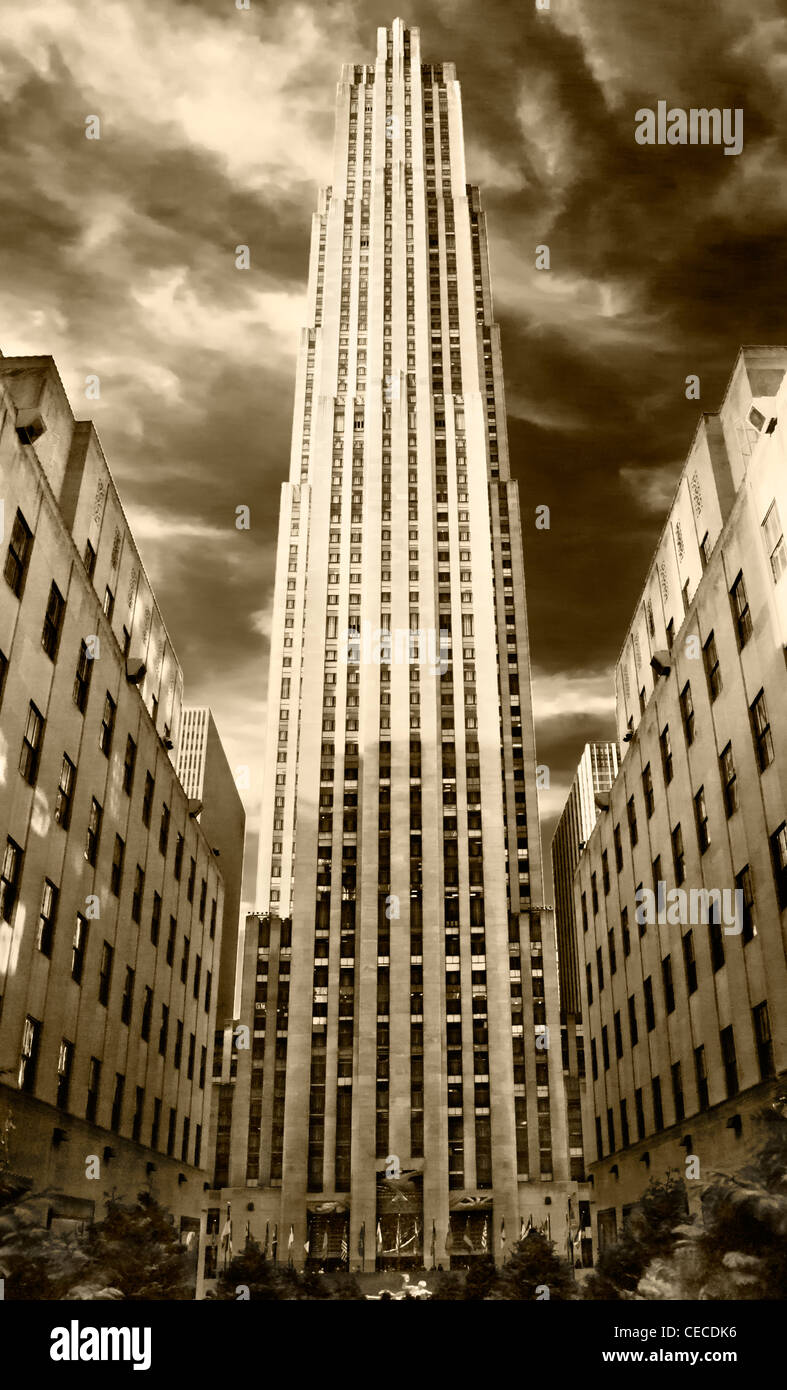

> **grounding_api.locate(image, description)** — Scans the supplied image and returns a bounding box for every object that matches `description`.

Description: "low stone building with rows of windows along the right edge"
[574,348,787,1247]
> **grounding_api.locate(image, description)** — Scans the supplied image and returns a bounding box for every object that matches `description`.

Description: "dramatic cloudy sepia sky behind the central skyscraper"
[0,0,787,889]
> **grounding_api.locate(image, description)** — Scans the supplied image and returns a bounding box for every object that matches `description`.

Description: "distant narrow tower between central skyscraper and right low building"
[552,742,617,1264]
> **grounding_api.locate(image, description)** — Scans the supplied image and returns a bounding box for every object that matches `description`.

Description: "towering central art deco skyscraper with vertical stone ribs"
[222,19,569,1268]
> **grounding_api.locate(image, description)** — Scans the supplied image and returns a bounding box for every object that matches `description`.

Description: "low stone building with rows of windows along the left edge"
[0,357,237,1239]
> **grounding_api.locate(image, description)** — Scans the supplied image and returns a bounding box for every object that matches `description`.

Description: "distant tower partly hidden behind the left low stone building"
[175,706,246,1027]
